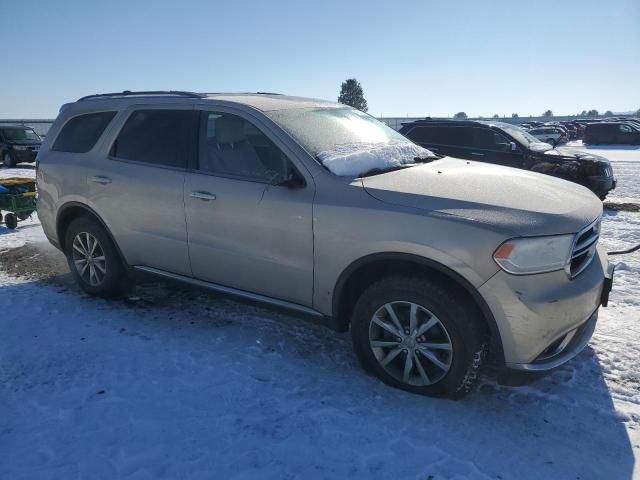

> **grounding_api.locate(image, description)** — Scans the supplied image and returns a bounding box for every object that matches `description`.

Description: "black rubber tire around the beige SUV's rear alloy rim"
[64,216,130,298]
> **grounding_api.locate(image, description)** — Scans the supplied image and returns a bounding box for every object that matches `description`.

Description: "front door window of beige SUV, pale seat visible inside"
[198,112,293,183]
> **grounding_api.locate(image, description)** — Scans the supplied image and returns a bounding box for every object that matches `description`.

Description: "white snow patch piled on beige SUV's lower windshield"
[317,142,435,177]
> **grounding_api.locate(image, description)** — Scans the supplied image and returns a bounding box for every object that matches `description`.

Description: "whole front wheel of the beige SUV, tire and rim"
[351,276,486,398]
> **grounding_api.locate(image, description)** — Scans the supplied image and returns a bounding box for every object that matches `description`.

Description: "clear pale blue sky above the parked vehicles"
[0,0,640,118]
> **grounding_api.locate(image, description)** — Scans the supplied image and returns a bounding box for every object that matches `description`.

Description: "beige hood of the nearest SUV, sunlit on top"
[362,157,602,236]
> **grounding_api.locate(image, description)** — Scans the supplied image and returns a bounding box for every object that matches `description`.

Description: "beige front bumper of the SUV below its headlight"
[479,246,612,370]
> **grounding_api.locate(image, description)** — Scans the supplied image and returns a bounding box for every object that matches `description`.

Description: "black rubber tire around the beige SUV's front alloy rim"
[351,276,487,398]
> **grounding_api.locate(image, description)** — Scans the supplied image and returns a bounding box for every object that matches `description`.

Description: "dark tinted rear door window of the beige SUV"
[111,109,192,168]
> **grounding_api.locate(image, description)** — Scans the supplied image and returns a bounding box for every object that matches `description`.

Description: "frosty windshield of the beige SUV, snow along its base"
[267,107,436,177]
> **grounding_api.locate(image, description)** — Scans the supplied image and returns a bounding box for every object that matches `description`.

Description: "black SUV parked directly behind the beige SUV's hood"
[400,120,616,199]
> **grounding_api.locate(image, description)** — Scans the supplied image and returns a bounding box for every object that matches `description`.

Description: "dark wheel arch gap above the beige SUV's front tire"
[332,252,504,363]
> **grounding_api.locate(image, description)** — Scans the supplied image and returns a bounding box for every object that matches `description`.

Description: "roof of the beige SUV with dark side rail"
[69,91,345,112]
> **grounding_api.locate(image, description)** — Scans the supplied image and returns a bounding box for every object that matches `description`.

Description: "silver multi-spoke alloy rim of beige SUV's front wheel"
[369,301,453,386]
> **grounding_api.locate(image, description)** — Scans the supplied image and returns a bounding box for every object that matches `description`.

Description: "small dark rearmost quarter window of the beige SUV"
[51,112,116,153]
